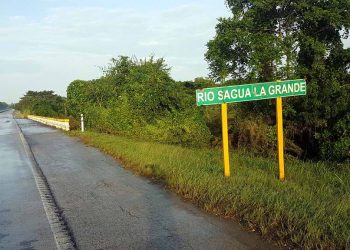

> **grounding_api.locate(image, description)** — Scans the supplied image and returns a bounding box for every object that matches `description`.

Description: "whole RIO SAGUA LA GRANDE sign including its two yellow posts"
[196,79,306,181]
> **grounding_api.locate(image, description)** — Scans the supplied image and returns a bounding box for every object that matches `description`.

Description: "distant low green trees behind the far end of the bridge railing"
[15,91,66,117]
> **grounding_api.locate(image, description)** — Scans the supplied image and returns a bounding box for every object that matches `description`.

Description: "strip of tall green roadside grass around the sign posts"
[71,132,350,249]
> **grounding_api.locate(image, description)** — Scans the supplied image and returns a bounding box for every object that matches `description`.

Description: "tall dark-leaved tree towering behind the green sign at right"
[206,0,350,161]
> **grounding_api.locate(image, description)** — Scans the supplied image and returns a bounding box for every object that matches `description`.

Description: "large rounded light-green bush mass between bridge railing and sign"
[67,56,211,146]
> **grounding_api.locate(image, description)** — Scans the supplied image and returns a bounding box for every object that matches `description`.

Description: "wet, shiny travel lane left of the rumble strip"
[0,111,56,249]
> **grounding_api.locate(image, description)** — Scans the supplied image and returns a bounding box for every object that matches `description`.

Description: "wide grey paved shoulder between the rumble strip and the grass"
[18,119,275,249]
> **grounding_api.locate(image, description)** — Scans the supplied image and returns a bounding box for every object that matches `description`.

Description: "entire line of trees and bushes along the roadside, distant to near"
[16,0,350,161]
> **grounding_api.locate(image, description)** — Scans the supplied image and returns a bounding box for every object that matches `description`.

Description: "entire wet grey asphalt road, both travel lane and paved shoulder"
[0,112,275,249]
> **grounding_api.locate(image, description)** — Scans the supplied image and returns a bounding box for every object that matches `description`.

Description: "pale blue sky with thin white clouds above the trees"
[0,0,230,103]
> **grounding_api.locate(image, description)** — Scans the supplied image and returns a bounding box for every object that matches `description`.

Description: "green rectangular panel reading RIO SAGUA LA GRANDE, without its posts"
[196,79,306,106]
